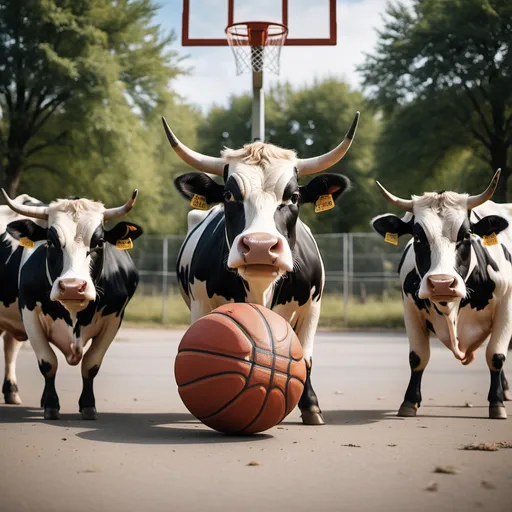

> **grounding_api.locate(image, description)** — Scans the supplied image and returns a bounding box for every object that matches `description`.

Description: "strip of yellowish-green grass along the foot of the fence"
[125,295,404,330]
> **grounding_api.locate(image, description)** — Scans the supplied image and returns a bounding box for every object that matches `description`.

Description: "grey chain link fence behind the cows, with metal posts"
[131,233,406,324]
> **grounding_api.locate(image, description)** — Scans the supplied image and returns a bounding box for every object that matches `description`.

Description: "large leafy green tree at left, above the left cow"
[0,0,183,209]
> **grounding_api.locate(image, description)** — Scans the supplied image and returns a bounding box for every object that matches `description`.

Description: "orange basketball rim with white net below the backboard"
[226,21,288,75]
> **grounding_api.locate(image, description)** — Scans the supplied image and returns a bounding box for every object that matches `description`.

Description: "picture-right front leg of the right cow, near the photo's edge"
[485,296,512,419]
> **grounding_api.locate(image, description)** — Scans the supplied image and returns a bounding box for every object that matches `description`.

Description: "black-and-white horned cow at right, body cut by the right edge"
[372,170,512,419]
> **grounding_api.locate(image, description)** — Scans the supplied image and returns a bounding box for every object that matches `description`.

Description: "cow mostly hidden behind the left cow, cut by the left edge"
[0,194,46,405]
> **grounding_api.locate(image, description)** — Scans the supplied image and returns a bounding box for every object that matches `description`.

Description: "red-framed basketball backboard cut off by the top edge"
[181,0,337,46]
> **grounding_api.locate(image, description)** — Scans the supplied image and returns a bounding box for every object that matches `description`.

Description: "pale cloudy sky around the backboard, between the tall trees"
[156,0,411,111]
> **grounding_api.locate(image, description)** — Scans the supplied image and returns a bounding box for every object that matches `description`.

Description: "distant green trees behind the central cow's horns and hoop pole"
[187,79,378,233]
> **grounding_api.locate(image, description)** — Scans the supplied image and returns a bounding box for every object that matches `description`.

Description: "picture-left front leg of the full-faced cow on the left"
[22,316,60,420]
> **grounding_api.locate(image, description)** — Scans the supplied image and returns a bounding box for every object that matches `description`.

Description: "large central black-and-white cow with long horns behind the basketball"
[163,112,359,425]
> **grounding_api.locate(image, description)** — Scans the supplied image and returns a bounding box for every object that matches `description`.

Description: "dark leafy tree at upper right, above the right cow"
[359,0,512,201]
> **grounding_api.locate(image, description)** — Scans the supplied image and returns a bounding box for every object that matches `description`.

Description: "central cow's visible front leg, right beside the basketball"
[295,301,325,425]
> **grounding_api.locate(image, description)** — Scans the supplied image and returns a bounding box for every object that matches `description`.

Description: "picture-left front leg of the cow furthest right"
[397,298,430,418]
